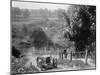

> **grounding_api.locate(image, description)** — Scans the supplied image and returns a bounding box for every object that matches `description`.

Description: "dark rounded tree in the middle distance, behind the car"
[31,28,49,49]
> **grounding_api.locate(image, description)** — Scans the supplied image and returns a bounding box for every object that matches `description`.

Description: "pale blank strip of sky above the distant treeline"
[12,1,69,10]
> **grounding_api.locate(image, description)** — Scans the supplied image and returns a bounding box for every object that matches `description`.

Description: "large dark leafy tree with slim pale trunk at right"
[65,6,96,63]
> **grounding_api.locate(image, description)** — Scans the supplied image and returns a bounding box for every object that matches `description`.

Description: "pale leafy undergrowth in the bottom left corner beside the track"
[11,57,39,75]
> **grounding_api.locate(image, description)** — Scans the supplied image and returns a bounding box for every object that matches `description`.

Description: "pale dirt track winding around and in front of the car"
[25,50,95,72]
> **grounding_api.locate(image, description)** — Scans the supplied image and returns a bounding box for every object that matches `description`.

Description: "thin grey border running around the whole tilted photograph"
[10,0,97,74]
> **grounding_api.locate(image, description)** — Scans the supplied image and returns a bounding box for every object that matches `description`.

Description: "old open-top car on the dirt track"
[36,55,57,71]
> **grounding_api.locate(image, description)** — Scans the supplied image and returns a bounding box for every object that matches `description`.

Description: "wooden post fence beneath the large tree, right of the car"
[59,50,94,64]
